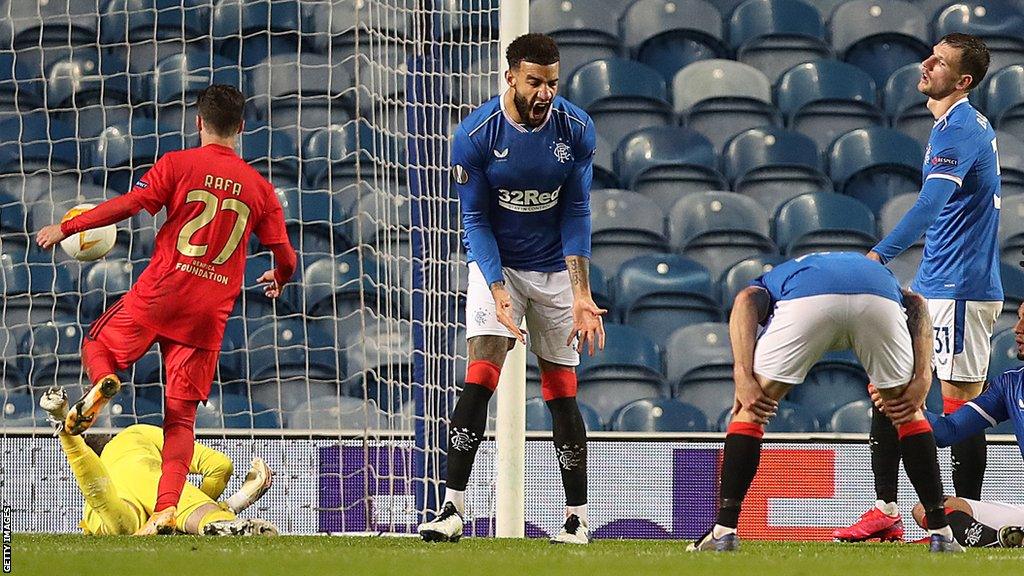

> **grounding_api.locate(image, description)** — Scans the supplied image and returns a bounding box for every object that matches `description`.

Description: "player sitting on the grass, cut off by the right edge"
[871,304,1024,547]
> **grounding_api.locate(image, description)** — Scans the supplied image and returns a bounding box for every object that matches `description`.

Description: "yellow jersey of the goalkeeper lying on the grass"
[82,424,233,534]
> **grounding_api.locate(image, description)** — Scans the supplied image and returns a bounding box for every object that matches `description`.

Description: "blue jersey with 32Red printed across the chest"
[452,91,596,284]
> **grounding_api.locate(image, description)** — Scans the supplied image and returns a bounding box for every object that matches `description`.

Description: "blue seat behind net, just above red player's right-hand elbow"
[276,188,353,256]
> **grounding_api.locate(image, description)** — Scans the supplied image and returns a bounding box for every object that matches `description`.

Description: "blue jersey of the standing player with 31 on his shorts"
[911,97,1002,300]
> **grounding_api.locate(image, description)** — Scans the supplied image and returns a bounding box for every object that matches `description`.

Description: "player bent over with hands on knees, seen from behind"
[687,252,964,552]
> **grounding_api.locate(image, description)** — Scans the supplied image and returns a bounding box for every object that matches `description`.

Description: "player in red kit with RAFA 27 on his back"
[36,85,296,534]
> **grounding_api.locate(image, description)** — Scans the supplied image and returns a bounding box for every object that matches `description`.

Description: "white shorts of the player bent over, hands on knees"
[754,294,913,388]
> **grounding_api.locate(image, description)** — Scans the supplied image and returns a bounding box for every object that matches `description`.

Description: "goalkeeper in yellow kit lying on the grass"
[39,387,278,536]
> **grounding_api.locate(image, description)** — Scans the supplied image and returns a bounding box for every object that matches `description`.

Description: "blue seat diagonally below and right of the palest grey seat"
[723,127,833,218]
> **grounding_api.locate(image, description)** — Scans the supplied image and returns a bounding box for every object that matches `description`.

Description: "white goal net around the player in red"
[0,0,507,533]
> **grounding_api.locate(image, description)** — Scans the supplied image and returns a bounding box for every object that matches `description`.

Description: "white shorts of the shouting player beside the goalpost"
[466,262,580,366]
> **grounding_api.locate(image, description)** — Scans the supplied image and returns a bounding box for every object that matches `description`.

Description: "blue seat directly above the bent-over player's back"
[775,192,878,257]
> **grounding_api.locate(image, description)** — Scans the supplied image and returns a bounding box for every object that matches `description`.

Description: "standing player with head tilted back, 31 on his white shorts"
[834,34,1002,541]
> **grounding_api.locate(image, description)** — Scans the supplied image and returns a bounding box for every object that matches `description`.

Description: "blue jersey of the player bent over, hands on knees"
[751,252,903,307]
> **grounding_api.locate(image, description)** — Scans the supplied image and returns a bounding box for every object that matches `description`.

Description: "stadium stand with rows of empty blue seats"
[6,0,1024,431]
